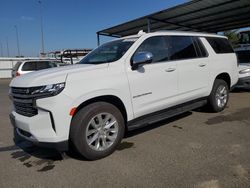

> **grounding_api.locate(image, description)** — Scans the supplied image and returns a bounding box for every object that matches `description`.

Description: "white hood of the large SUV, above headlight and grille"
[10,63,108,87]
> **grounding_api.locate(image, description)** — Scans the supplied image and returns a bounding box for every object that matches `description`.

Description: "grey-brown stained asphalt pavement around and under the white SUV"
[0,79,250,188]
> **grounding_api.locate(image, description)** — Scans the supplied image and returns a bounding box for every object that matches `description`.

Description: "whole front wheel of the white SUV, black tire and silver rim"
[70,102,125,160]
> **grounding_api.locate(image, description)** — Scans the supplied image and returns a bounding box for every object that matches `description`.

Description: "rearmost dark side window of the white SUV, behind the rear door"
[206,37,234,54]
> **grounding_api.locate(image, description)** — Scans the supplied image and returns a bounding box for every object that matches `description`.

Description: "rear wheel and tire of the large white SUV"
[208,79,229,112]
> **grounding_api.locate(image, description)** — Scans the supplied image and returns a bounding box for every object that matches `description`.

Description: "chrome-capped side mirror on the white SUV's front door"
[131,52,153,70]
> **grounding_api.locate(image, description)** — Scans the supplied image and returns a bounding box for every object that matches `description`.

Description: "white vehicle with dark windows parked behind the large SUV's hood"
[11,60,60,78]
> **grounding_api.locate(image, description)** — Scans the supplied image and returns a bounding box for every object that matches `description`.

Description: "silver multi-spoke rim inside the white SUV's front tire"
[86,113,118,151]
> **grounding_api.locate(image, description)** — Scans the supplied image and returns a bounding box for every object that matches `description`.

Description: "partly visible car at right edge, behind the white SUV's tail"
[235,44,250,88]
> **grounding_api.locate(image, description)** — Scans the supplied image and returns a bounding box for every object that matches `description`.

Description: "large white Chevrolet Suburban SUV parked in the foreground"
[10,31,238,160]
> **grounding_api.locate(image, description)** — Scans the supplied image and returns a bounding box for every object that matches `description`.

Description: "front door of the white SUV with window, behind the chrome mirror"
[127,36,178,117]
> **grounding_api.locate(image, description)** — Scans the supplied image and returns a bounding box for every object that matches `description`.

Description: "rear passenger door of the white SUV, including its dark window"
[168,36,209,102]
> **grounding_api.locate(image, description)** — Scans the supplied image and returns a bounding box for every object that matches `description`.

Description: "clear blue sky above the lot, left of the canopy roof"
[0,0,187,56]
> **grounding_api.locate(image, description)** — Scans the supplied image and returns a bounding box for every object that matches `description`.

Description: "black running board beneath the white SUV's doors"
[127,98,207,131]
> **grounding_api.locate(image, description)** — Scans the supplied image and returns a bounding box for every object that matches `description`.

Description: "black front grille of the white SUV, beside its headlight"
[11,87,38,117]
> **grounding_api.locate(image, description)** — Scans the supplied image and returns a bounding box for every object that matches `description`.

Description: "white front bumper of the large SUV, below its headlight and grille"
[10,90,72,150]
